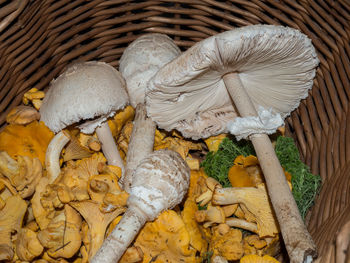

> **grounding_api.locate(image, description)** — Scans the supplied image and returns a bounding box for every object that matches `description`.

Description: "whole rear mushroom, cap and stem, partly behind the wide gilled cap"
[119,33,181,191]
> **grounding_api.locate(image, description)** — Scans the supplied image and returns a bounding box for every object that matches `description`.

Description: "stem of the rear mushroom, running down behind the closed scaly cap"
[121,103,156,192]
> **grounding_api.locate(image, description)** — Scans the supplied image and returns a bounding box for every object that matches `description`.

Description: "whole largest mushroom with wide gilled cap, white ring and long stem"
[146,25,319,262]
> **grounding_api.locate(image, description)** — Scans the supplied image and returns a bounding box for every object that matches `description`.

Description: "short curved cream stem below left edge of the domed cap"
[45,131,70,183]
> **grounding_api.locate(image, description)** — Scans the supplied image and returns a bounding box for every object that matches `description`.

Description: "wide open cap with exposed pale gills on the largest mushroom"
[146,25,319,139]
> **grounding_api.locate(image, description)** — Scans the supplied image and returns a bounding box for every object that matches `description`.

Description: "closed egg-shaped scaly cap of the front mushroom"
[128,149,190,220]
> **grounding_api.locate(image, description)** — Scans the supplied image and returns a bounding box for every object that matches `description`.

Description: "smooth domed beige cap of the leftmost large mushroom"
[40,61,129,133]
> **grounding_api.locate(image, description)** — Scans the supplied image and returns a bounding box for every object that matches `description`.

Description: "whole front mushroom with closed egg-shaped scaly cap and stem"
[91,150,190,263]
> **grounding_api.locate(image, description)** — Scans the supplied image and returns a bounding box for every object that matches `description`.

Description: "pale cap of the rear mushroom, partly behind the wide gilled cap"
[119,33,181,107]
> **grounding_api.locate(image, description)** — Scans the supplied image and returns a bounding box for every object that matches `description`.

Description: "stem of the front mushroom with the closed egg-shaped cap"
[91,207,147,263]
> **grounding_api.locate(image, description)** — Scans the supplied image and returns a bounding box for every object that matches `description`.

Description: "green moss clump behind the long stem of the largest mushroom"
[201,136,321,219]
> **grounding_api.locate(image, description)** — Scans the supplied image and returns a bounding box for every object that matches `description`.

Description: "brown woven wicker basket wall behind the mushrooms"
[0,0,350,262]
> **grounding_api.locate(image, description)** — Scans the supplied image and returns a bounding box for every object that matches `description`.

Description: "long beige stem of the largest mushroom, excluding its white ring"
[223,73,317,263]
